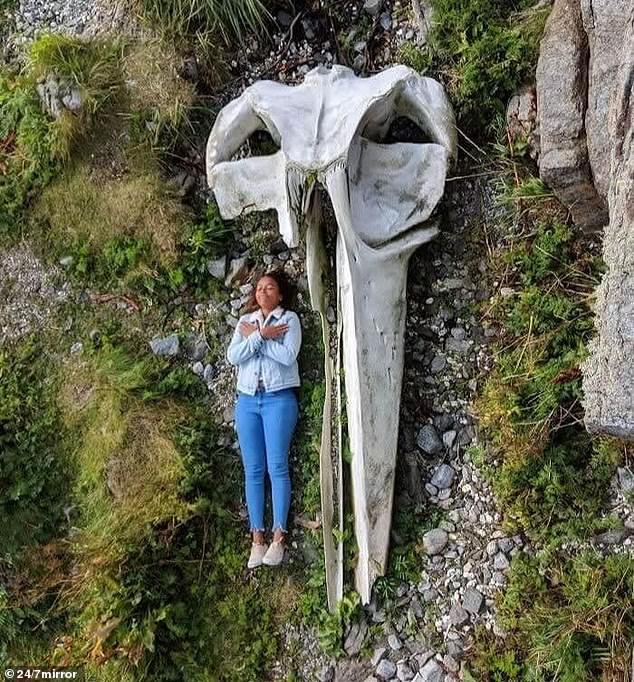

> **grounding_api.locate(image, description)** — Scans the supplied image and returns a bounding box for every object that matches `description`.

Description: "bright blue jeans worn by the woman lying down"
[235,388,298,532]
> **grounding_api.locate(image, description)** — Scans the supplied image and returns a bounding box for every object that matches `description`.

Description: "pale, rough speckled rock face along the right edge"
[584,6,634,440]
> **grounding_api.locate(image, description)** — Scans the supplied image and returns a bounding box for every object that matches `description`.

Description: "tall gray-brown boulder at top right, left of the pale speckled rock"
[536,0,608,231]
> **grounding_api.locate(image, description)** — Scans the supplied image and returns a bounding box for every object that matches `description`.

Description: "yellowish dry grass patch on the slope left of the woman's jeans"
[60,352,191,568]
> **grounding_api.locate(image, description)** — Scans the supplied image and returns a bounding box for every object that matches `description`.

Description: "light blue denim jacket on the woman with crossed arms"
[227,306,302,395]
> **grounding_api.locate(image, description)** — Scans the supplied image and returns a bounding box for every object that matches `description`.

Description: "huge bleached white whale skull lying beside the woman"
[207,66,456,608]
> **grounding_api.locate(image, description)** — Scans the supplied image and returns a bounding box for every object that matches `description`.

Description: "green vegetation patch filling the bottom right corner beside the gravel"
[466,552,634,682]
